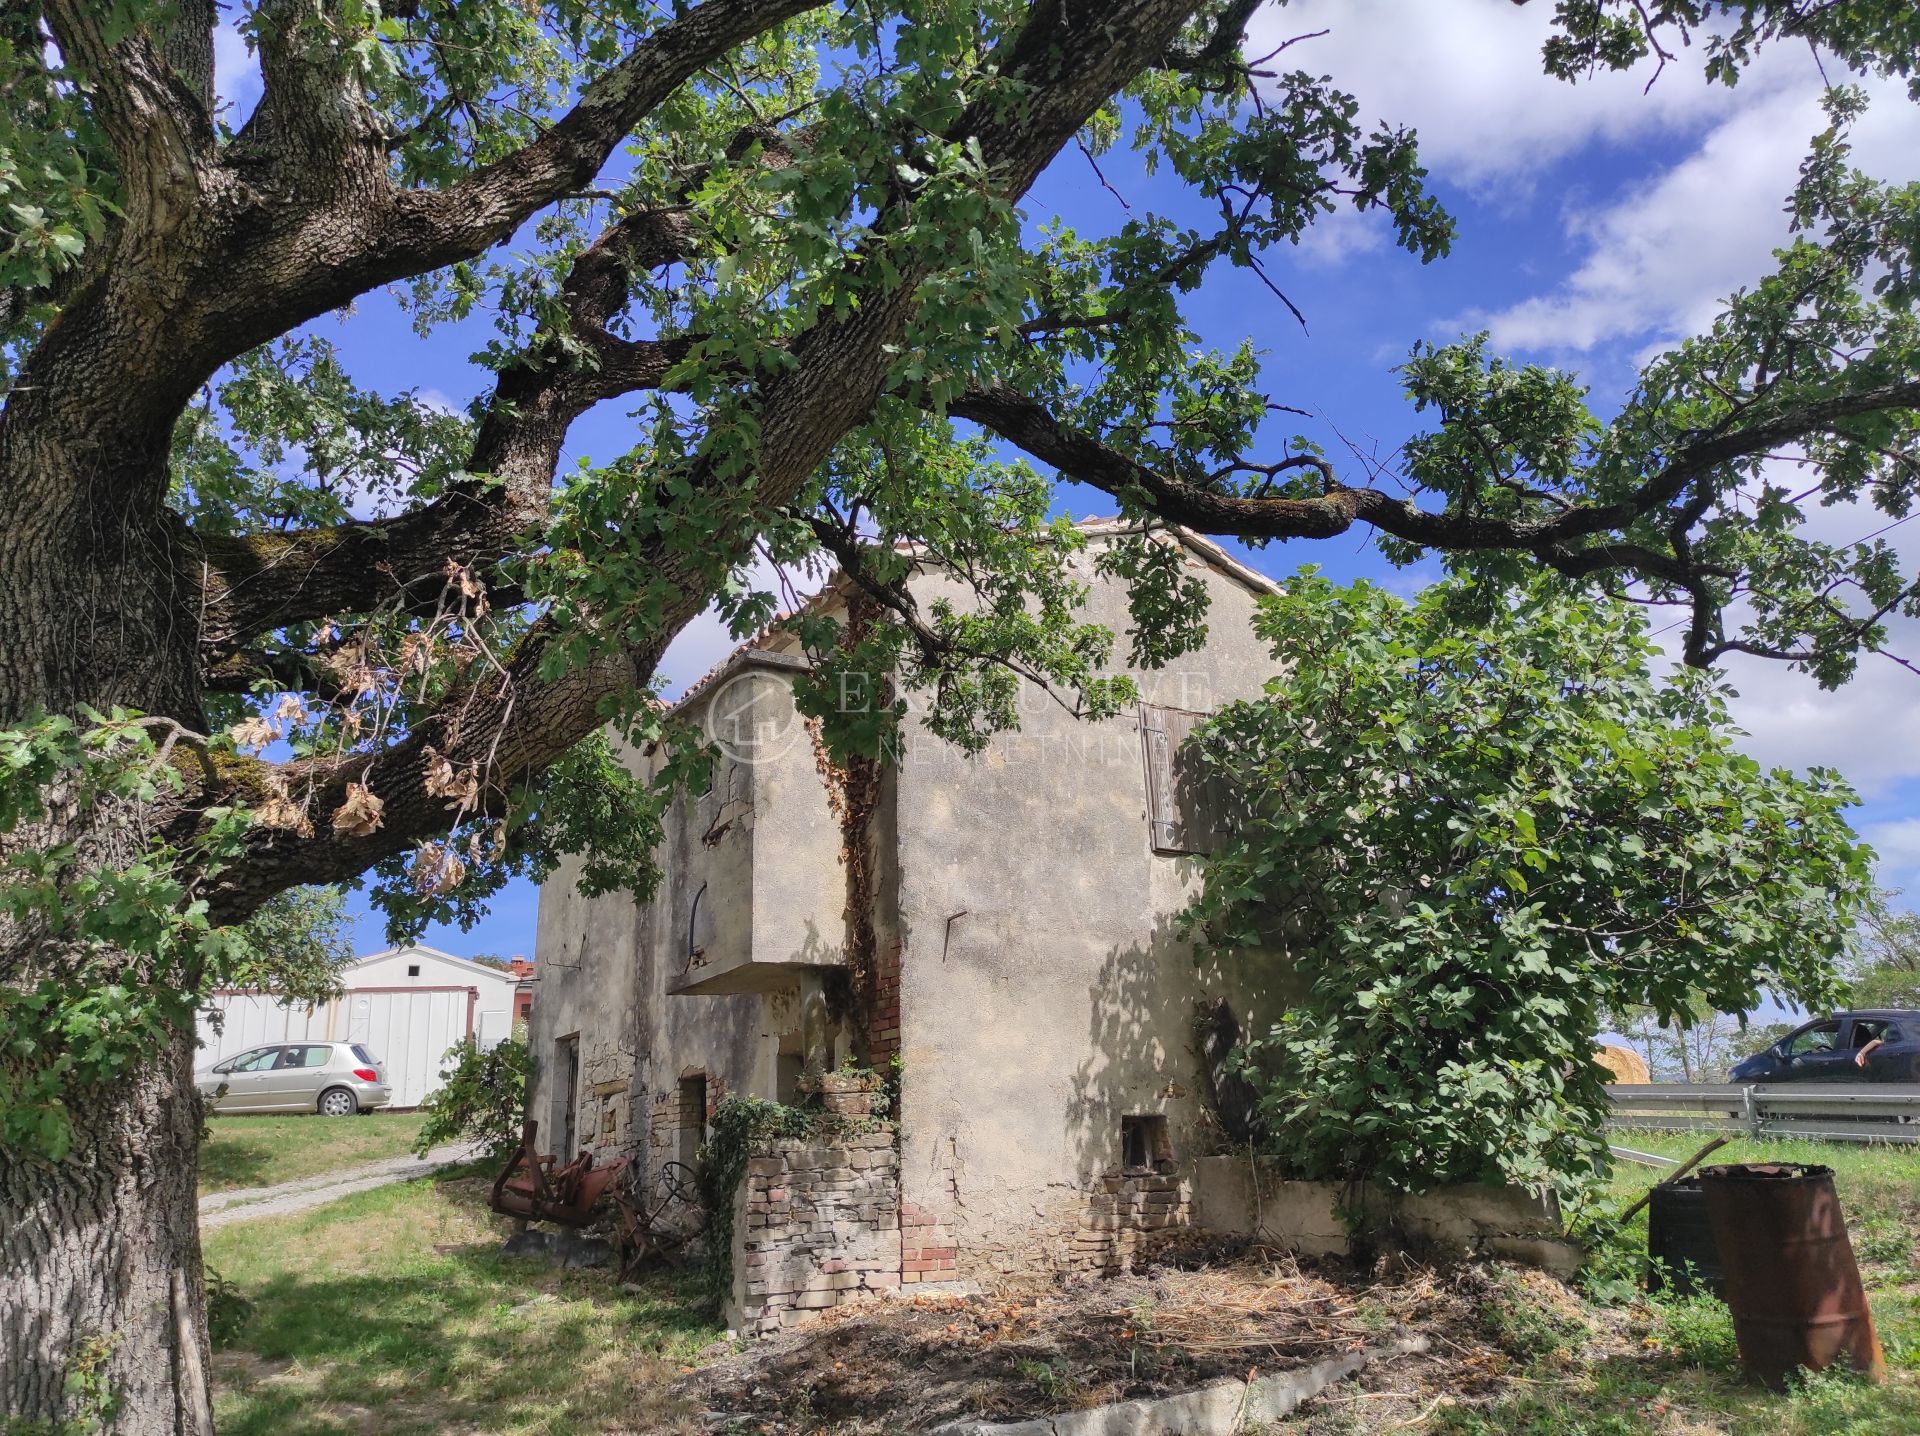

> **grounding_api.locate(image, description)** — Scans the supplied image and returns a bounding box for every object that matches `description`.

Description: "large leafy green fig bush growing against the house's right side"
[1188,572,1870,1194]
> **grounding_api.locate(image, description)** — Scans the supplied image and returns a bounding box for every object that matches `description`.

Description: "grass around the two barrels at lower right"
[1397,1133,1920,1436]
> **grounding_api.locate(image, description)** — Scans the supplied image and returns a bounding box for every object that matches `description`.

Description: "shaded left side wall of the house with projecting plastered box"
[528,664,845,1181]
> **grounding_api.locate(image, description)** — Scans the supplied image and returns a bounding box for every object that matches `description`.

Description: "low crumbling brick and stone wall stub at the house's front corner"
[726,1119,902,1336]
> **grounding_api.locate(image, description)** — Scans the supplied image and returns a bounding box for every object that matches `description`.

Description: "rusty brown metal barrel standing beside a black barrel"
[1699,1161,1887,1388]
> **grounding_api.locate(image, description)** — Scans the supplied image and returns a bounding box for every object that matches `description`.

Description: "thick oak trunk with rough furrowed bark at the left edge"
[0,412,213,1436]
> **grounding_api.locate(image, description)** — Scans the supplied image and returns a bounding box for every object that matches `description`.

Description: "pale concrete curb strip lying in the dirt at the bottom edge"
[927,1336,1430,1436]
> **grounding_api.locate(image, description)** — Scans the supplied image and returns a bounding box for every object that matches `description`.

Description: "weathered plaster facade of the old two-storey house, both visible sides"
[532,524,1297,1304]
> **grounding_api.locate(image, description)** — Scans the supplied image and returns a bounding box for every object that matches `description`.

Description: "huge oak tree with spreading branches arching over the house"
[0,0,1920,1432]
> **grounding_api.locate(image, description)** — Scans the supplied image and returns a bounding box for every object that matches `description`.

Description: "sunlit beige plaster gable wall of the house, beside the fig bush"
[895,551,1283,1277]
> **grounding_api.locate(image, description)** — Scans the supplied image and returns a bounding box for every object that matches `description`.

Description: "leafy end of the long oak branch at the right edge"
[1382,92,1920,687]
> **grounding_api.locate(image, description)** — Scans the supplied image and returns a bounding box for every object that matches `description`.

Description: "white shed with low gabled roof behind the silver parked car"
[198,945,520,1108]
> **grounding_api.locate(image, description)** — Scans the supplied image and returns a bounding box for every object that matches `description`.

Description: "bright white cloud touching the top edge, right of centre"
[1248,0,1812,198]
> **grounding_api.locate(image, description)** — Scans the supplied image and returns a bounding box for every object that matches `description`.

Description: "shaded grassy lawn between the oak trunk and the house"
[205,1167,720,1436]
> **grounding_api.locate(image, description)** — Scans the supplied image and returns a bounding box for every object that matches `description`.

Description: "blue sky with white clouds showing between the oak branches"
[210,0,1920,954]
